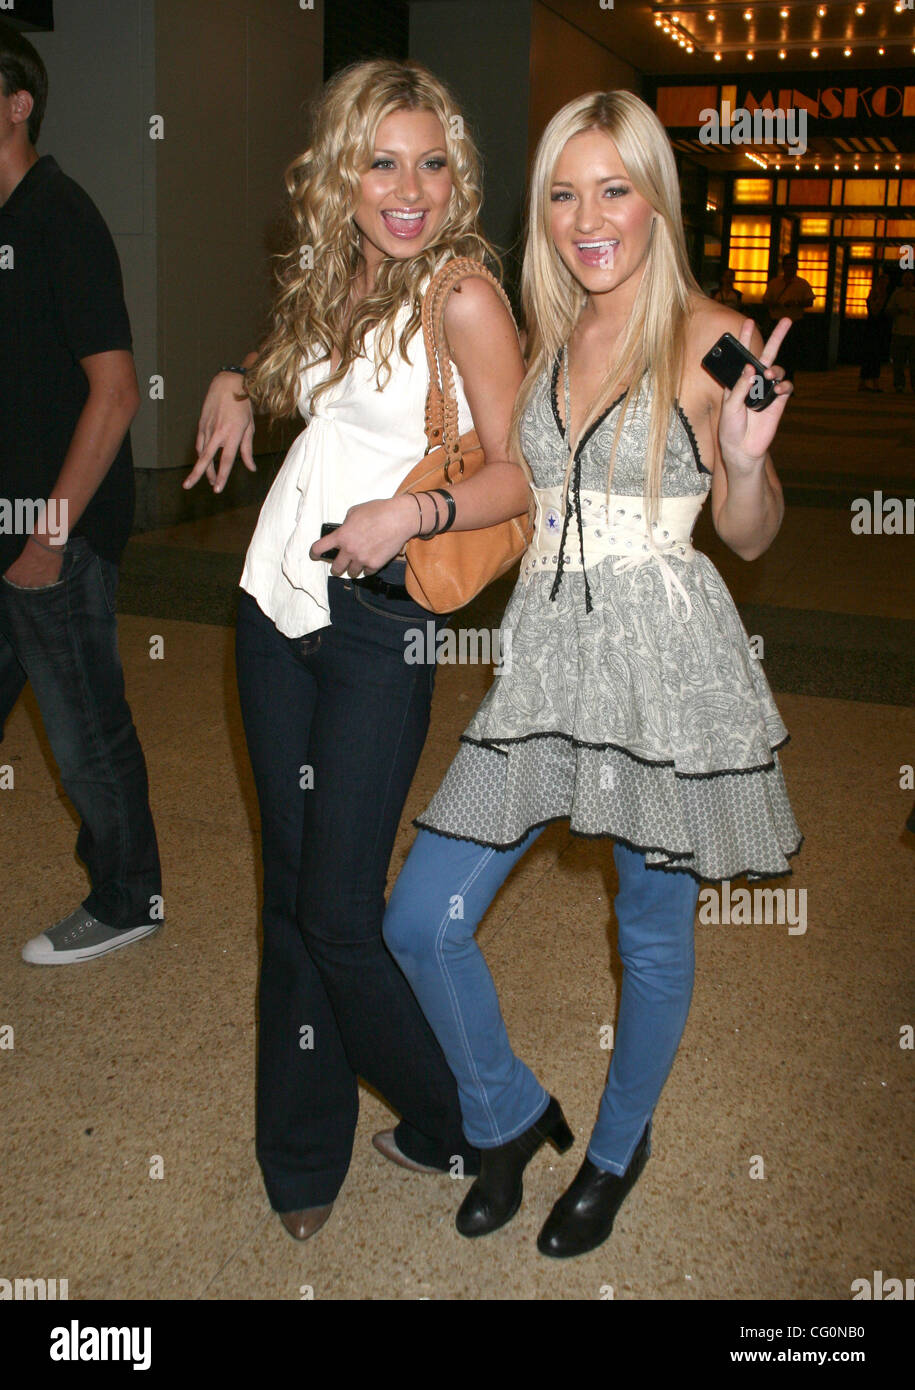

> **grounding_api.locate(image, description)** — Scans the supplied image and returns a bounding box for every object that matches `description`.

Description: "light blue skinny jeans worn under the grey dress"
[384,827,699,1173]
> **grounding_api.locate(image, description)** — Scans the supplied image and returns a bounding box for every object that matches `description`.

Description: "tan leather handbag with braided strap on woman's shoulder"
[395,256,533,613]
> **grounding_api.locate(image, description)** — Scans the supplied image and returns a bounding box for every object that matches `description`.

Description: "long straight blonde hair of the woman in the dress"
[512,92,701,520]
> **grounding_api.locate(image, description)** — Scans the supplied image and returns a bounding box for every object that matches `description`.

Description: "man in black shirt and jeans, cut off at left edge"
[0,25,161,965]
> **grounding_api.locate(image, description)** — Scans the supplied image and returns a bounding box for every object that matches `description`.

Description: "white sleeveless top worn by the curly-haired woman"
[239,304,474,637]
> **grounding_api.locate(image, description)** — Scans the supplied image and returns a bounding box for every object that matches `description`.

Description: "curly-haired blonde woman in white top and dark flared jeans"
[185,60,528,1240]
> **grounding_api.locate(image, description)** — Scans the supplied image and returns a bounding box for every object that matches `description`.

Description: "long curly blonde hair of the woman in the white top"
[246,58,498,420]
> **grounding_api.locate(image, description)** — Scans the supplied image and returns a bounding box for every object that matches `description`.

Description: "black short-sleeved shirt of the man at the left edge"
[0,154,133,574]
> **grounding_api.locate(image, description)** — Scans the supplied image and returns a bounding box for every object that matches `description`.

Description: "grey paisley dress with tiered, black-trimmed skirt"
[416,363,802,880]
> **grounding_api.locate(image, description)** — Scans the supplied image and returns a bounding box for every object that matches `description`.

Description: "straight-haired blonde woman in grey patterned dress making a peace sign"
[384,92,801,1257]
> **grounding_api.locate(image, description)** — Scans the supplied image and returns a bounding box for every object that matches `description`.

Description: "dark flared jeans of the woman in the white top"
[236,564,480,1212]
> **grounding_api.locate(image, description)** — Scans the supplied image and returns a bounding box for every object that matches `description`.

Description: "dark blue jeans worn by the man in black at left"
[0,537,161,930]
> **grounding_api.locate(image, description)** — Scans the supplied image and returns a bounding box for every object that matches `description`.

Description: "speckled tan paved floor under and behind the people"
[0,370,915,1300]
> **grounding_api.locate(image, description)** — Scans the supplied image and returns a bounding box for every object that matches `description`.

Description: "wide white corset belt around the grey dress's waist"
[521,487,706,619]
